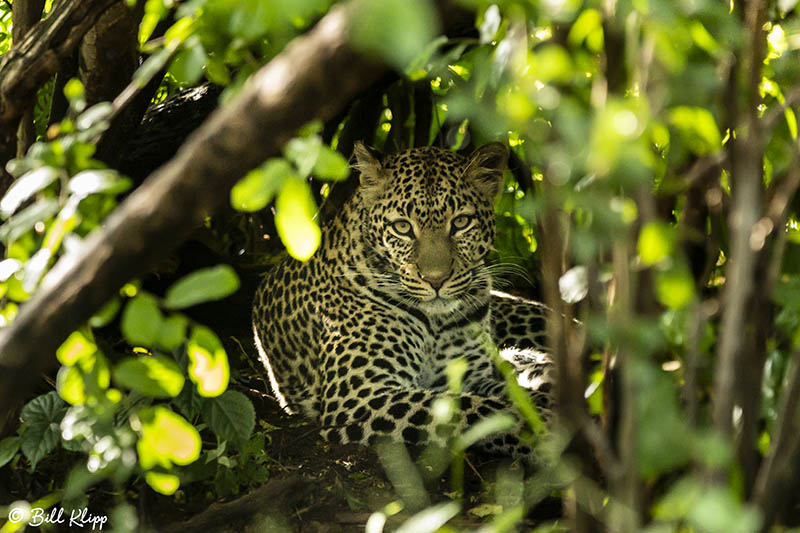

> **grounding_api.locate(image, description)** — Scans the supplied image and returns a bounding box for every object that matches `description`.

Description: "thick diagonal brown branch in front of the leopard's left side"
[0,4,396,409]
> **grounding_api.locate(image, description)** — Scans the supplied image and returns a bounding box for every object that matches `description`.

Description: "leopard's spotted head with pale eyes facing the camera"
[355,143,508,314]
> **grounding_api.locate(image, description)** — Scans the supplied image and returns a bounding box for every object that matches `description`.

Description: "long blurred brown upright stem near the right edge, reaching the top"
[714,0,765,437]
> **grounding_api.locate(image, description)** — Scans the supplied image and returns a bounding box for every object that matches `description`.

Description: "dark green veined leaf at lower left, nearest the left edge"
[20,391,67,470]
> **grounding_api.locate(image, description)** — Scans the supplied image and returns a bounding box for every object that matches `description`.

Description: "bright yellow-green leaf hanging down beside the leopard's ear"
[275,179,322,261]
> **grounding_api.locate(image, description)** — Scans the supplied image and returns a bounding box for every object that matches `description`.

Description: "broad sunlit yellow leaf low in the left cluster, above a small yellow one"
[136,406,202,470]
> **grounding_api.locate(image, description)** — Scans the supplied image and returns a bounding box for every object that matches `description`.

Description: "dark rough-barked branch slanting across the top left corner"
[0,0,120,185]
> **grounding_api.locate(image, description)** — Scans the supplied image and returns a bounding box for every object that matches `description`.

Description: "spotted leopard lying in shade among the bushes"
[252,142,554,458]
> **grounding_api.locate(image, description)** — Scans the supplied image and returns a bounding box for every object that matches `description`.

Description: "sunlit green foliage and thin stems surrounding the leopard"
[0,0,800,531]
